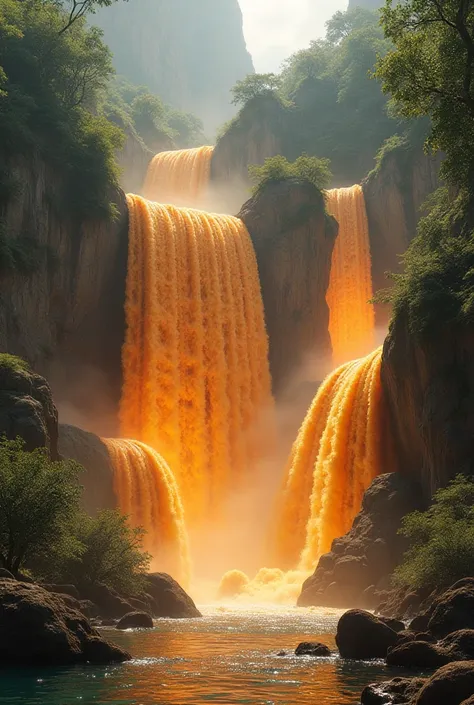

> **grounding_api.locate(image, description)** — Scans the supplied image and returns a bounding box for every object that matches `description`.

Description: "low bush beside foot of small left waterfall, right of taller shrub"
[55,510,150,595]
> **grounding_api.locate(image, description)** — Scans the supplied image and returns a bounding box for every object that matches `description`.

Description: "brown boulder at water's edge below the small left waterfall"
[146,573,202,619]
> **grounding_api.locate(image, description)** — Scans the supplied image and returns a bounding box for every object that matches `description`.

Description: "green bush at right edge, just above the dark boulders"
[395,475,474,590]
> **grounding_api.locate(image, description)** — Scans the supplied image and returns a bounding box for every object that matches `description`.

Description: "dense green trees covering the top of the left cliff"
[0,0,122,217]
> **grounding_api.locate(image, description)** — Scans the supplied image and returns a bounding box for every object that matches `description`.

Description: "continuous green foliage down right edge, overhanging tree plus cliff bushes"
[377,0,474,335]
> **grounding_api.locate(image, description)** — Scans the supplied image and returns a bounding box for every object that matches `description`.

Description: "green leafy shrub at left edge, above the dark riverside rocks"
[0,438,81,574]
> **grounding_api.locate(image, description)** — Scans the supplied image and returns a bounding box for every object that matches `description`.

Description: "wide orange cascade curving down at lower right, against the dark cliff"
[272,348,390,570]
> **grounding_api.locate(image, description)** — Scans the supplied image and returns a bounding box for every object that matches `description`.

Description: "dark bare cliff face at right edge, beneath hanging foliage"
[381,317,474,500]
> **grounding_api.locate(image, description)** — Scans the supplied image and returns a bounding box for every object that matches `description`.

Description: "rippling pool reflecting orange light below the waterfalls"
[0,607,394,705]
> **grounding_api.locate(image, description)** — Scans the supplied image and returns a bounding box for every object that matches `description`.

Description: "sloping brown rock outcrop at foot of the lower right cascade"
[298,473,419,607]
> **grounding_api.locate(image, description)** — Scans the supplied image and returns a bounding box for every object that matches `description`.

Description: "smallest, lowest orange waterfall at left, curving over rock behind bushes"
[102,438,190,583]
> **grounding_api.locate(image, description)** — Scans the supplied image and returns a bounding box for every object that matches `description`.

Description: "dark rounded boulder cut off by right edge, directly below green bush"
[428,584,474,638]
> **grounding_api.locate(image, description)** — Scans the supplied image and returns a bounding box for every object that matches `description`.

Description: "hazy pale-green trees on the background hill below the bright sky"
[224,8,406,185]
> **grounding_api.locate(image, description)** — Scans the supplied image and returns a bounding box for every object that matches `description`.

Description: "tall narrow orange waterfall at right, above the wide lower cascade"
[326,185,375,365]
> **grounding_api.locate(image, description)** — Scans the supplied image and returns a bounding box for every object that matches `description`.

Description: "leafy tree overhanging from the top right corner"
[376,0,474,186]
